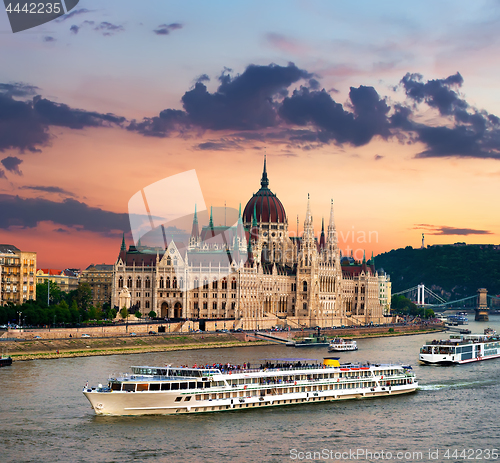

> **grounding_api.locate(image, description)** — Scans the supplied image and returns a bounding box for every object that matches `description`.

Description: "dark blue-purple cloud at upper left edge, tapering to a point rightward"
[0,90,125,153]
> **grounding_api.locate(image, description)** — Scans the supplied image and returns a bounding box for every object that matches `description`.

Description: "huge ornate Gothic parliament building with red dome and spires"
[111,160,391,330]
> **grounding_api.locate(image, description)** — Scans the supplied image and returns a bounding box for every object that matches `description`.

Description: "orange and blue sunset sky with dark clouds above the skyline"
[0,0,500,269]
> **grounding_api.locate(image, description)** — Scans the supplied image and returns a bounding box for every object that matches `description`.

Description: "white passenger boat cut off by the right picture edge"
[419,328,500,365]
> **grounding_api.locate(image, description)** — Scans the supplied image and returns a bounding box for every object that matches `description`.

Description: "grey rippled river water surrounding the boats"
[0,315,500,463]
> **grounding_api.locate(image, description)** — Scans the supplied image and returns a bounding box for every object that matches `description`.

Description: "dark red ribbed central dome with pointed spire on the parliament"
[243,158,286,224]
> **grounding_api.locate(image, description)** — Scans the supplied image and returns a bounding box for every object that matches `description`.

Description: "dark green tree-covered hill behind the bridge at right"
[375,245,500,300]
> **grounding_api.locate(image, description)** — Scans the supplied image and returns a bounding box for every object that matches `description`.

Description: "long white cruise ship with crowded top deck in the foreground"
[83,359,418,416]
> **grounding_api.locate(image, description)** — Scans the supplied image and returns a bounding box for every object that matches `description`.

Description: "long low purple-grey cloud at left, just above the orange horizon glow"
[0,194,130,235]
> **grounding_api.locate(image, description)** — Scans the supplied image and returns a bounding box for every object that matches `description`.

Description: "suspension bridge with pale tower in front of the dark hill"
[393,284,500,321]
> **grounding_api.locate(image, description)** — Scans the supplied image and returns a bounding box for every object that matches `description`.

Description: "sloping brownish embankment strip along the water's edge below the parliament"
[0,327,444,361]
